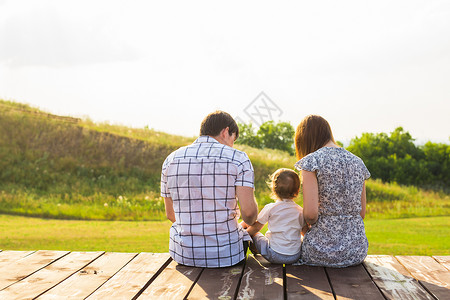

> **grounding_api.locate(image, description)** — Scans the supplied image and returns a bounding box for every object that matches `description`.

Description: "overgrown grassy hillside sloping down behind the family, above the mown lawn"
[0,100,450,220]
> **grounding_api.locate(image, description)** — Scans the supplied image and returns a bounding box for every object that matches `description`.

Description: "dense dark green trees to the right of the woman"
[347,127,450,190]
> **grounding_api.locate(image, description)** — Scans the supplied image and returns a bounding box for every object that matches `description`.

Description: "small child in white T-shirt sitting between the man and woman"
[241,169,305,264]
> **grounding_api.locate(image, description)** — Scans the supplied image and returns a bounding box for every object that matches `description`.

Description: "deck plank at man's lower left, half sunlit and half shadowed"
[139,261,203,300]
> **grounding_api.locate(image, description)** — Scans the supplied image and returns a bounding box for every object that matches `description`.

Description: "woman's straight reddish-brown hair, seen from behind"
[295,115,336,159]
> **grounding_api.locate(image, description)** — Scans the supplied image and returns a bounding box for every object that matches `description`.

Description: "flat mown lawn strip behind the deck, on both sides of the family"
[0,215,450,255]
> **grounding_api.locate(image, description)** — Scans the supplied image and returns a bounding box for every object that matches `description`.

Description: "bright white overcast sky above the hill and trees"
[0,0,450,144]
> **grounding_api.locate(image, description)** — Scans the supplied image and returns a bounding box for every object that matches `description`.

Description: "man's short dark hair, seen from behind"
[200,110,239,139]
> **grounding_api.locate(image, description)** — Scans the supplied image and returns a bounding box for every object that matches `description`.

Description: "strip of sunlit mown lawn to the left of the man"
[0,215,170,252]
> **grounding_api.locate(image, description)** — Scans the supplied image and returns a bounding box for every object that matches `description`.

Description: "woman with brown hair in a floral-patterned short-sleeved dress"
[295,115,370,267]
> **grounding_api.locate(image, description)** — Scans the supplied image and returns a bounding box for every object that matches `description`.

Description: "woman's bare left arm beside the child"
[301,170,319,225]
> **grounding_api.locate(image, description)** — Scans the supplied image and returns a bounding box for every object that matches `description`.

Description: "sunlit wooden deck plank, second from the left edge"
[0,250,69,290]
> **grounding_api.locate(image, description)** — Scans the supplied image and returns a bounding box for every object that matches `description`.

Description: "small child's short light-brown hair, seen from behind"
[269,168,300,199]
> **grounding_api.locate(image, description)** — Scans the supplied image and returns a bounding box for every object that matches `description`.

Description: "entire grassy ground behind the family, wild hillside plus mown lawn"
[0,99,450,255]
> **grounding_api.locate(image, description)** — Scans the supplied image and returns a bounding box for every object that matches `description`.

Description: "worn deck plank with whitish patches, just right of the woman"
[364,255,433,300]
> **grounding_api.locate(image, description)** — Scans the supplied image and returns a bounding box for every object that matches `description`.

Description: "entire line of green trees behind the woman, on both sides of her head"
[237,121,450,190]
